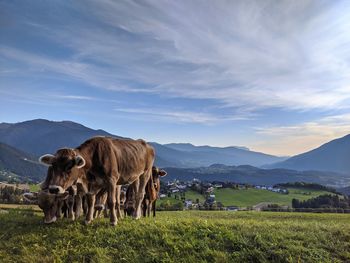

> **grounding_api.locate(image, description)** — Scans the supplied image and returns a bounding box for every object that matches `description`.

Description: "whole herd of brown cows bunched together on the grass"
[24,137,166,225]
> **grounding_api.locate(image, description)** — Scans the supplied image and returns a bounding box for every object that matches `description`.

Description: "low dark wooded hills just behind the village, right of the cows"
[164,164,350,187]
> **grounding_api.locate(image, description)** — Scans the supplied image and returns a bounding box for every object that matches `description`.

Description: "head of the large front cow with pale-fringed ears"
[39,148,85,194]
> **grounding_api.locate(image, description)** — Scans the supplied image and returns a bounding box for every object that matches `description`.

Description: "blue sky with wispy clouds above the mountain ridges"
[0,0,350,156]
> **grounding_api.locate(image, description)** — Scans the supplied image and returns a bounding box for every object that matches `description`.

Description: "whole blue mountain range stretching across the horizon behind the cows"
[0,119,350,187]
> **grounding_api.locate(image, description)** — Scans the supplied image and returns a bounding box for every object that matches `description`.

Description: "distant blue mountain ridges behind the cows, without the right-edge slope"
[0,119,285,168]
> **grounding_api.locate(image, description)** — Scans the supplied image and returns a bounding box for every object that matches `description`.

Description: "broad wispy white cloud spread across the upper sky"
[2,0,350,111]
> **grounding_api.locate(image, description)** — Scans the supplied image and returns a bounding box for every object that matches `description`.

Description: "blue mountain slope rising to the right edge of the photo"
[264,135,350,175]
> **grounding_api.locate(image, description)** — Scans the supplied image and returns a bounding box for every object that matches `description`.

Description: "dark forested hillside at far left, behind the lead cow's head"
[0,143,47,182]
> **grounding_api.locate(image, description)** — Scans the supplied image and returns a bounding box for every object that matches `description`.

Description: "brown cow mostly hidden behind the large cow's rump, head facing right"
[142,166,167,217]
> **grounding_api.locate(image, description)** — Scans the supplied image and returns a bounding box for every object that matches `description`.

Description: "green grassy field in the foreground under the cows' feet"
[0,210,350,262]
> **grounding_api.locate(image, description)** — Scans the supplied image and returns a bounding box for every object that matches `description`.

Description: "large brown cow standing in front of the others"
[40,137,155,225]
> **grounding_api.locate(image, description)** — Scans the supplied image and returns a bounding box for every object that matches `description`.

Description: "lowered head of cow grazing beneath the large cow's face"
[23,190,69,224]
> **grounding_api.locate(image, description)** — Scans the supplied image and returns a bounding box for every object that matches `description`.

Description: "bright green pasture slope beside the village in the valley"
[214,188,329,207]
